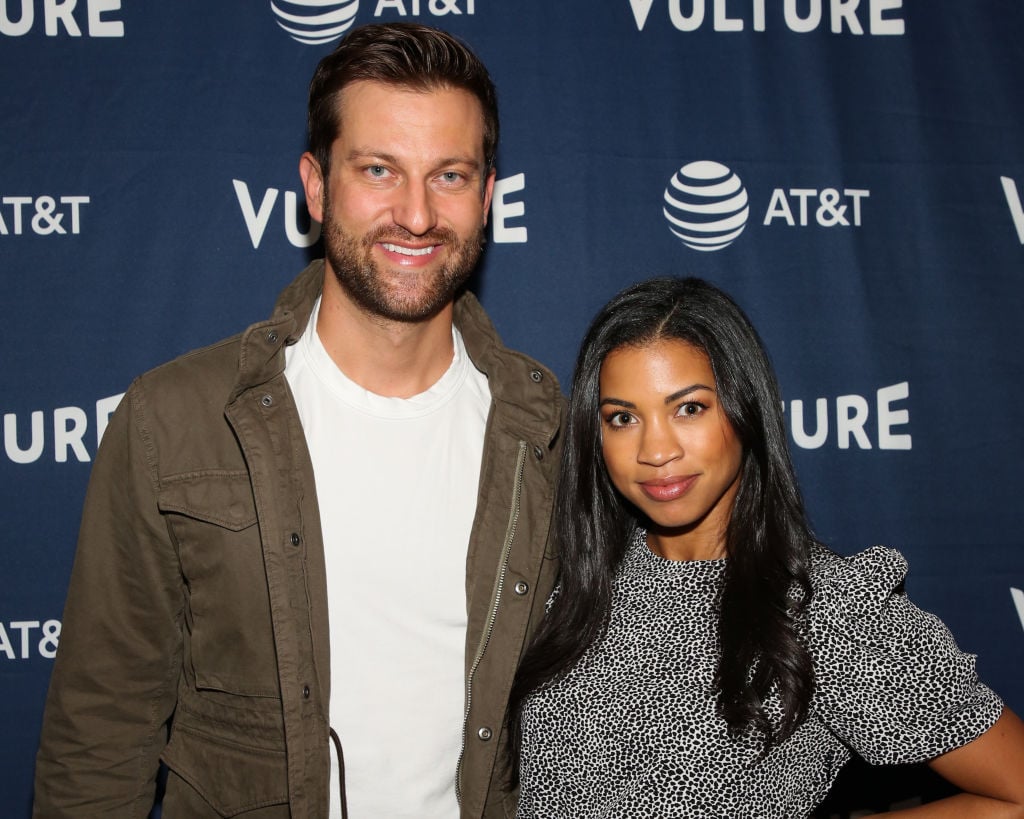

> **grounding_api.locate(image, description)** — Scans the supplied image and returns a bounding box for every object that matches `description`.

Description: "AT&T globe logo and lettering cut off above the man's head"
[270,0,476,45]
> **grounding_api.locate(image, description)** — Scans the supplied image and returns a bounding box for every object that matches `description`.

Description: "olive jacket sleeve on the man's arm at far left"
[33,382,183,819]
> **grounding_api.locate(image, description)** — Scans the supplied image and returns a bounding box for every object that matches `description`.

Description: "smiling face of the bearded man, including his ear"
[303,81,495,321]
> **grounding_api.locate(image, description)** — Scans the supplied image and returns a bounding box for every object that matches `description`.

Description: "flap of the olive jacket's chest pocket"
[157,470,256,531]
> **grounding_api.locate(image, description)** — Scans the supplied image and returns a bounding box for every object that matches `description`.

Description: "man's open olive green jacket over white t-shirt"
[35,261,563,819]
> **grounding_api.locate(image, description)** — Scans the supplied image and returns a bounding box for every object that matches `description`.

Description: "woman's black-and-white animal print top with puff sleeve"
[516,531,1002,819]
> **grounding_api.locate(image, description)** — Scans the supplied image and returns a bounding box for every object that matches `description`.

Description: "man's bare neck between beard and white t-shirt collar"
[316,272,455,398]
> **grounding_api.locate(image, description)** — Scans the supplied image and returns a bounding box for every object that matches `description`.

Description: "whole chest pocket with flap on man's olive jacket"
[159,470,280,697]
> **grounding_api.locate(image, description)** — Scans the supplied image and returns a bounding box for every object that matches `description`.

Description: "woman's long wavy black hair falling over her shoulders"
[509,278,815,781]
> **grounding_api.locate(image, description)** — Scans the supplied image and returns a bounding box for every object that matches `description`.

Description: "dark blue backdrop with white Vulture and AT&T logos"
[0,0,1024,818]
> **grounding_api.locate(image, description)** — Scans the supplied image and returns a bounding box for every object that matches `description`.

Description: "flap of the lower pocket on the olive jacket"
[161,726,288,816]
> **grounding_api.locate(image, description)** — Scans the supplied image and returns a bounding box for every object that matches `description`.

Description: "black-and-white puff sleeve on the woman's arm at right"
[808,547,1002,765]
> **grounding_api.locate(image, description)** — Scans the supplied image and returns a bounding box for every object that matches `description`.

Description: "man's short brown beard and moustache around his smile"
[323,202,484,322]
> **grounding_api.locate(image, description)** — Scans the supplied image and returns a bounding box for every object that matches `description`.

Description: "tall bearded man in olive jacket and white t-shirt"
[35,25,562,819]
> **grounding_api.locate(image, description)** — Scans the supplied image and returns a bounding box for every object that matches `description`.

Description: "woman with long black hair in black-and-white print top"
[510,278,1024,819]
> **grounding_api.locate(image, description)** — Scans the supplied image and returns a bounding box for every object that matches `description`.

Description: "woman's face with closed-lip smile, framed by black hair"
[599,339,743,560]
